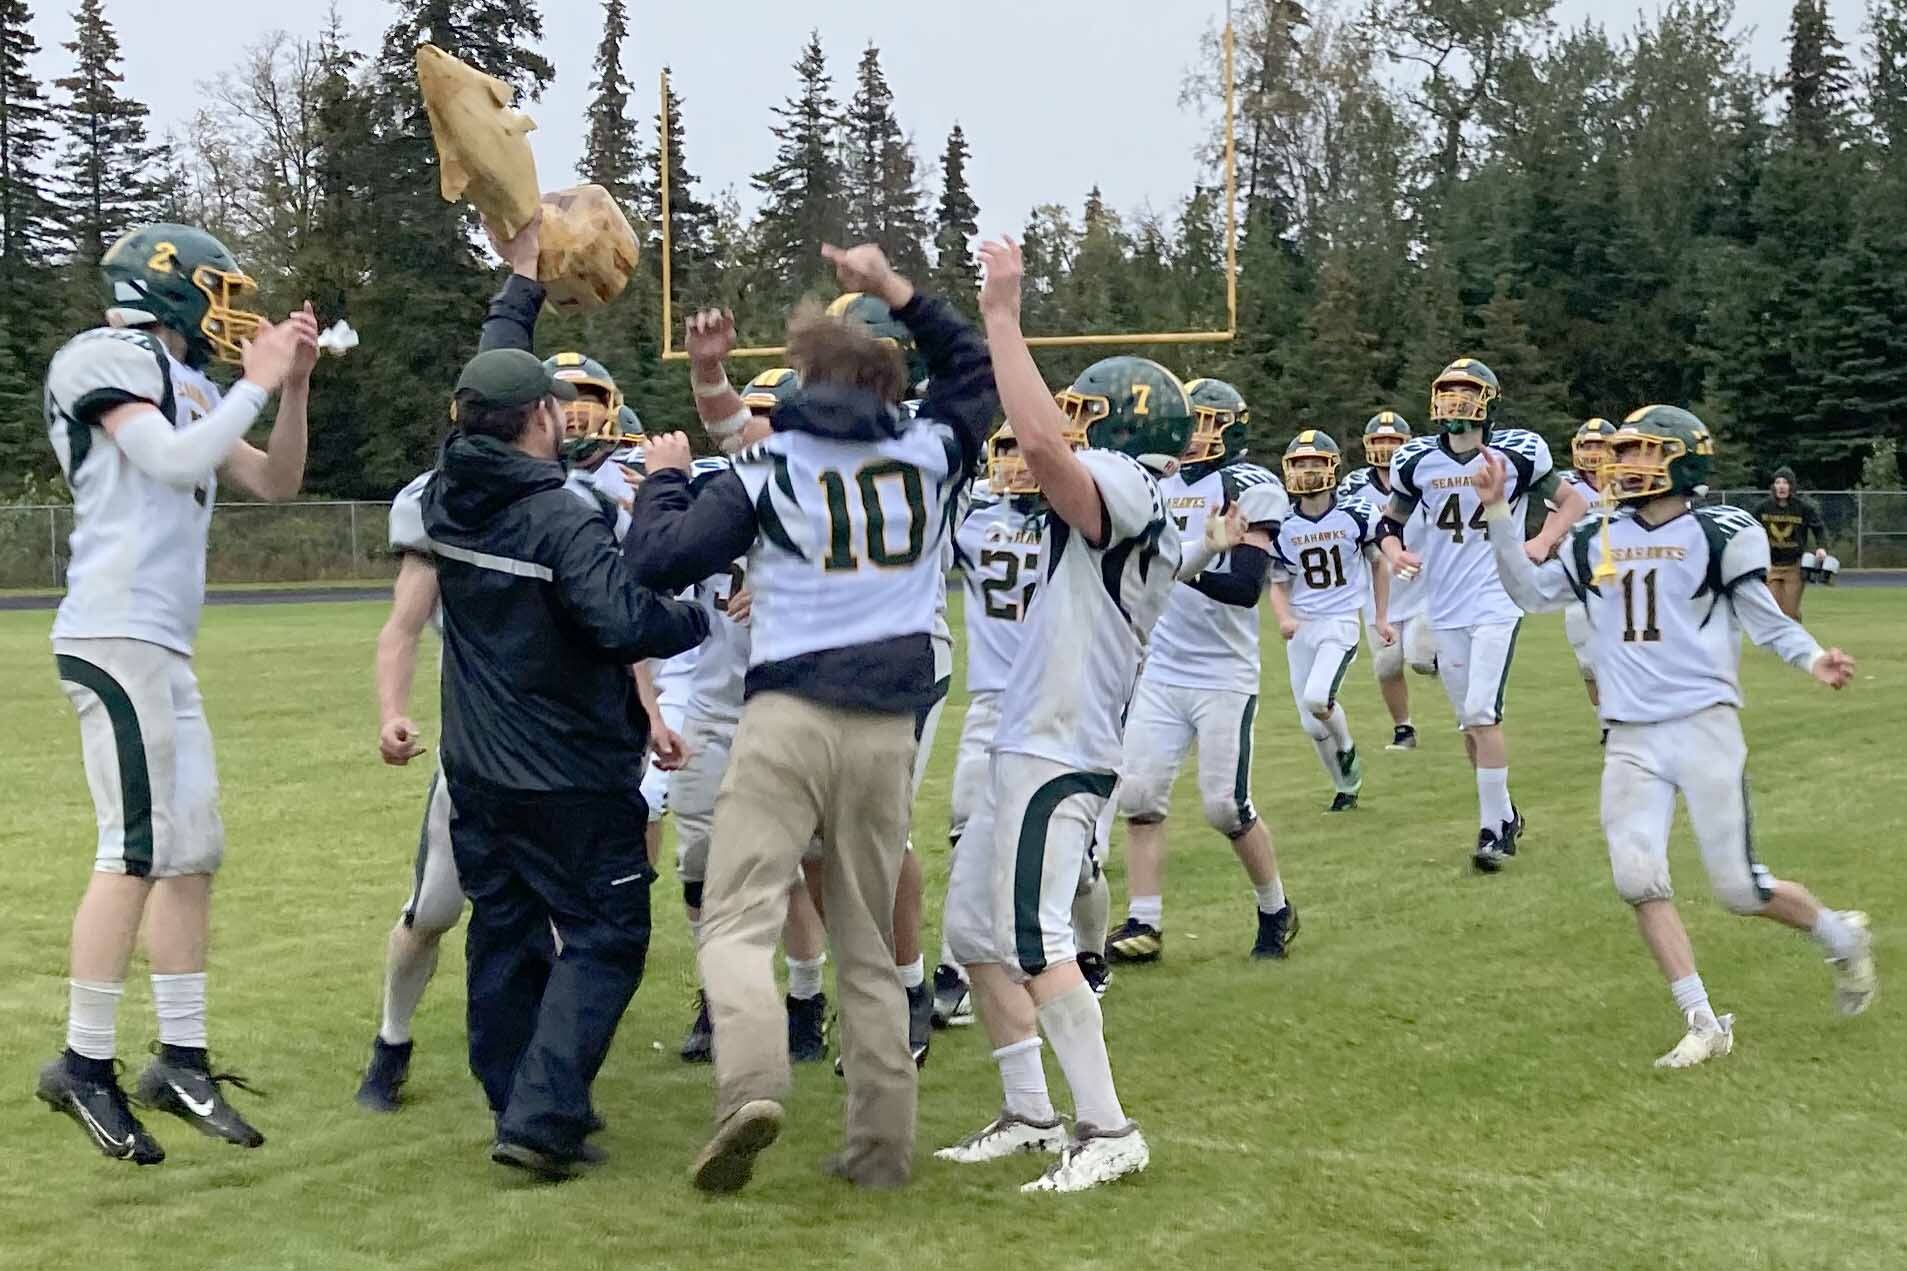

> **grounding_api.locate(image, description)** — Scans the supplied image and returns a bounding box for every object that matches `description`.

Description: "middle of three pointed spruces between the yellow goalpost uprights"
[841,44,927,277]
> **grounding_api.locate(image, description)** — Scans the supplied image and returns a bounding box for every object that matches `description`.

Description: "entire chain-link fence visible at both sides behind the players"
[0,490,1907,588]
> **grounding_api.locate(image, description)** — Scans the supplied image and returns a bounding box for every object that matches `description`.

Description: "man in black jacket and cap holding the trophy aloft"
[423,215,707,1177]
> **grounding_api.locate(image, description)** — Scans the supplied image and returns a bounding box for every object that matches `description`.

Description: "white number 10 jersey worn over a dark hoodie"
[734,420,961,666]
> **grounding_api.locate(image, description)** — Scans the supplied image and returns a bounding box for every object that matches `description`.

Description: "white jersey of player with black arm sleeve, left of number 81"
[1146,464,1289,693]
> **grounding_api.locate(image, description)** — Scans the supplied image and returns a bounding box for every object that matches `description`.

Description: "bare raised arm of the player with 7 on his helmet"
[980,239,1112,548]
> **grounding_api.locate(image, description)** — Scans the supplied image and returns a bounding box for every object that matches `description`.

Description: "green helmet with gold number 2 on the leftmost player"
[99,221,265,368]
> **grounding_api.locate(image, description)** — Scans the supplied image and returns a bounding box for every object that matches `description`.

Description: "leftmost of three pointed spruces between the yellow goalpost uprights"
[753,31,847,302]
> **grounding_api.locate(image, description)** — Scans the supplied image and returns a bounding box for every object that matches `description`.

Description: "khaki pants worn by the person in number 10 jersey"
[700,693,917,1183]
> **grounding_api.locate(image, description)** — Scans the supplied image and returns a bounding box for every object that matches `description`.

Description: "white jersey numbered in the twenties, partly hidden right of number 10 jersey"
[955,489,1047,693]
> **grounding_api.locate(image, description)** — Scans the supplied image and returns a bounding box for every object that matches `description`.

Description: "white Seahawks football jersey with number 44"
[1390,427,1554,630]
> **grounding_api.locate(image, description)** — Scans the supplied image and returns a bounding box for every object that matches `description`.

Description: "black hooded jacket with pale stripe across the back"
[423,419,709,792]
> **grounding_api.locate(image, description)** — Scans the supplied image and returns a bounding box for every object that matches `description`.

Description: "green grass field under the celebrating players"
[0,590,1907,1271]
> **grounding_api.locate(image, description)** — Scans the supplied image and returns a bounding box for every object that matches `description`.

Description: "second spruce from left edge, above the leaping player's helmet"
[53,0,162,265]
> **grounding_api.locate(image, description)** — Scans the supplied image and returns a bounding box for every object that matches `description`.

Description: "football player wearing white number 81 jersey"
[1272,427,1398,805]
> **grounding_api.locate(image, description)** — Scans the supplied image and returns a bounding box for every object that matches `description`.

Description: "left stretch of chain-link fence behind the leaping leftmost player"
[0,504,397,588]
